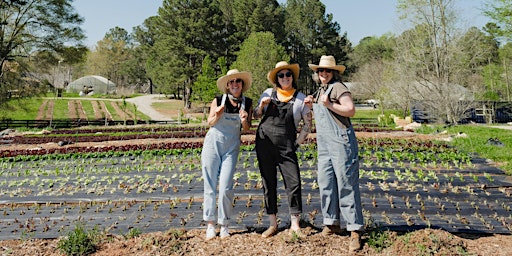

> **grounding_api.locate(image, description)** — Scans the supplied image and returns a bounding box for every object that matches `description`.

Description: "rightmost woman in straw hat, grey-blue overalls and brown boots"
[308,56,364,251]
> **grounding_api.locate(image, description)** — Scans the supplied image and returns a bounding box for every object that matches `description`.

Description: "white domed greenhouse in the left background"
[66,76,116,94]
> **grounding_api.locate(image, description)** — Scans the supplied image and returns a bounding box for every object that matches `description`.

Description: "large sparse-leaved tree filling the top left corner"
[0,0,84,104]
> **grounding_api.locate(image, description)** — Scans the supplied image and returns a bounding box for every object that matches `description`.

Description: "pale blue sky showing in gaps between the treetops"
[73,0,489,47]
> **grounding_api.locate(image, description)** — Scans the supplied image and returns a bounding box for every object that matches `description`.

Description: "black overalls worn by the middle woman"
[256,90,302,215]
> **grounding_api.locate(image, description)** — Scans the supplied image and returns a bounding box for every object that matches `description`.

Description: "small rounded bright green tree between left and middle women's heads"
[230,32,290,99]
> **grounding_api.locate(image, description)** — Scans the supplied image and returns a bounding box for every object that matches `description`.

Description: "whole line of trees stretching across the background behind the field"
[0,0,512,122]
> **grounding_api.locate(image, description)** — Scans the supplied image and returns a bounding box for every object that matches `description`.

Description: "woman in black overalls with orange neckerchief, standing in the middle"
[254,61,312,238]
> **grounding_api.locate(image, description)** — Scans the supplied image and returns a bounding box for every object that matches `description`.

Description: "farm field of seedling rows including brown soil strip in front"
[0,124,512,255]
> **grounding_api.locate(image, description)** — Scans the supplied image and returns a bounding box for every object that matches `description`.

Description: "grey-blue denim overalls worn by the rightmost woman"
[313,84,364,231]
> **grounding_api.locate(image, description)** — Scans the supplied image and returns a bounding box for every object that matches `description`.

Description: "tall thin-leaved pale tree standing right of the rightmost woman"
[395,0,478,123]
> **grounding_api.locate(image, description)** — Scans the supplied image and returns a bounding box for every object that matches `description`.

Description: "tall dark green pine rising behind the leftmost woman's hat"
[148,0,226,107]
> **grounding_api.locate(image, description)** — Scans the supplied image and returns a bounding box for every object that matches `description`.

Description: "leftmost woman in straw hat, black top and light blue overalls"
[201,69,252,240]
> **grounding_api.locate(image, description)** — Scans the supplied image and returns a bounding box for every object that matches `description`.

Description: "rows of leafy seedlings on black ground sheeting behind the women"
[0,124,512,240]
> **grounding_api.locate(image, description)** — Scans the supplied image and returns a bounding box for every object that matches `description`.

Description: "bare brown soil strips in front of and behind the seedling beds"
[0,132,512,256]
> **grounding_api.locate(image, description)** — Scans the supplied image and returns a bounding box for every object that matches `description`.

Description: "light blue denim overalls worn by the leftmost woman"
[201,94,245,225]
